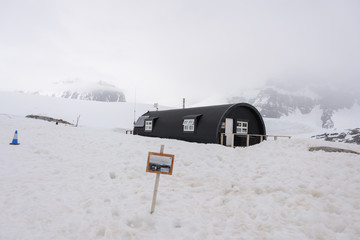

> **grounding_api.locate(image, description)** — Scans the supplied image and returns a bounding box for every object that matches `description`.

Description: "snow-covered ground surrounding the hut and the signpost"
[0,91,360,240]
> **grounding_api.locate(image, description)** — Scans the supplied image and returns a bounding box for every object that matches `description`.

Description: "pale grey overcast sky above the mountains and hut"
[0,0,360,105]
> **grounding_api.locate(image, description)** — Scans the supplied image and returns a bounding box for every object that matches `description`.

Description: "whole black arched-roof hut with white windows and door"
[134,103,266,146]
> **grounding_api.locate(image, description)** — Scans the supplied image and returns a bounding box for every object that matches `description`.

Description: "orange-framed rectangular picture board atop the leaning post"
[146,152,174,175]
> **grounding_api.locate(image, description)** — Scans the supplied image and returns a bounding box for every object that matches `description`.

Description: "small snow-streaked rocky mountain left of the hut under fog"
[31,80,126,102]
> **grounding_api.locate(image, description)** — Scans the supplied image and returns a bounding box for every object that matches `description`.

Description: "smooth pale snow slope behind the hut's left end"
[0,92,164,129]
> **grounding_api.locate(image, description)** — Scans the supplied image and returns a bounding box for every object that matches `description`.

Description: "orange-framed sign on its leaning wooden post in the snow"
[146,145,174,214]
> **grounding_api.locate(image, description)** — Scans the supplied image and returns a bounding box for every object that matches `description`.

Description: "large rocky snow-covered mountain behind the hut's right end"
[228,87,359,129]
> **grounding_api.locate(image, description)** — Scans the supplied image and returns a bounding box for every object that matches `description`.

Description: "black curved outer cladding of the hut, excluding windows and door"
[134,103,266,143]
